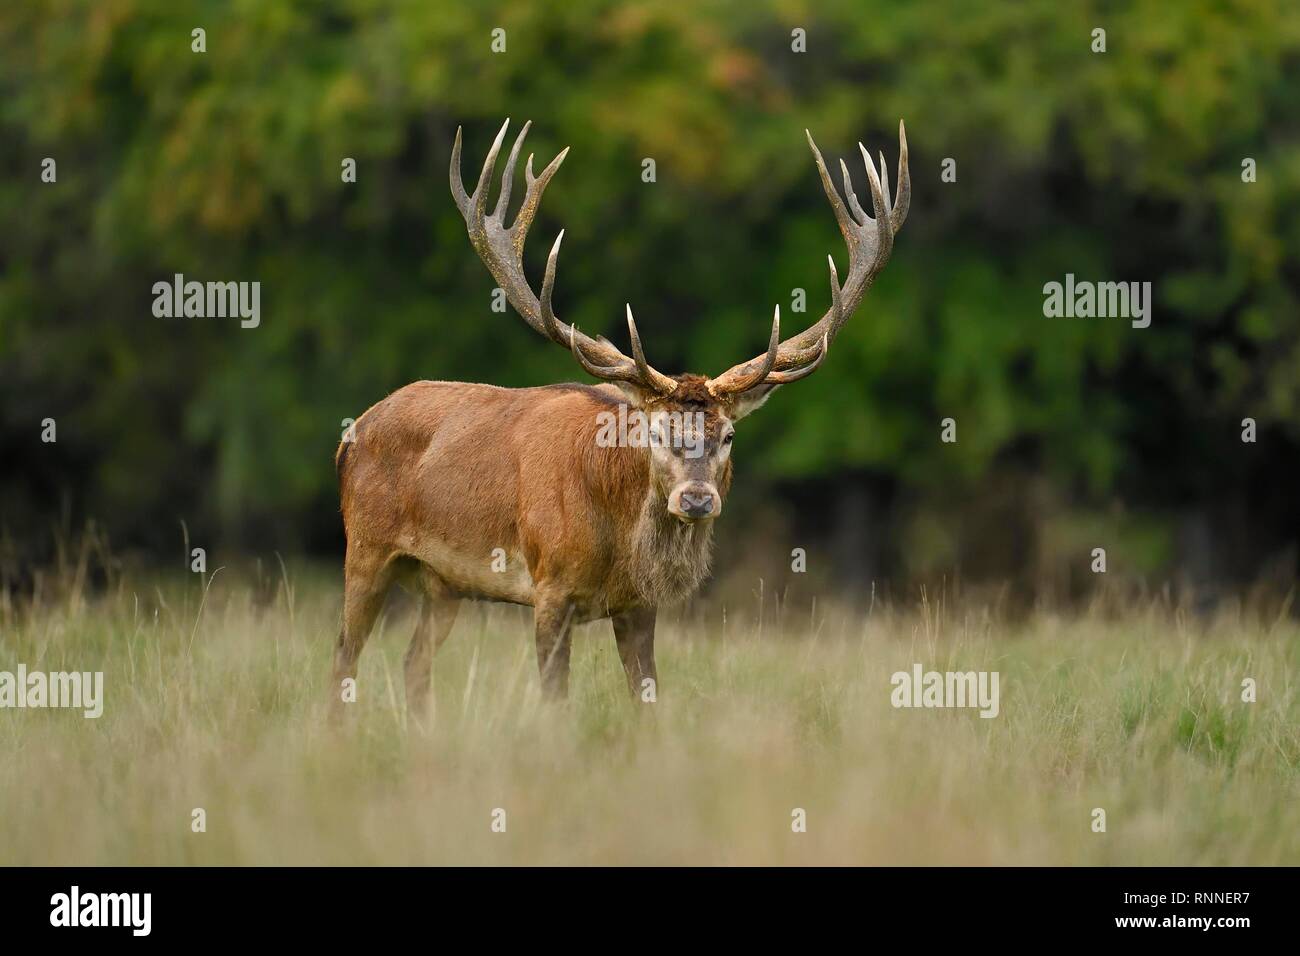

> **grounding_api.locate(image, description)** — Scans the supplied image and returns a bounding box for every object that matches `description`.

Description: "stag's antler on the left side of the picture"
[451,120,677,395]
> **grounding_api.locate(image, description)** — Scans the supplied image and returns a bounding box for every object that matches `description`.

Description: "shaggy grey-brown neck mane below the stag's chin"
[628,486,714,606]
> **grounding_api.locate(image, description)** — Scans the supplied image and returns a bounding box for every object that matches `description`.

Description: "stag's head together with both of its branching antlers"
[451,120,911,522]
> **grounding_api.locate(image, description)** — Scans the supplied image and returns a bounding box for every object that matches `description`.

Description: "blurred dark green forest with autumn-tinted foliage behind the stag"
[0,0,1300,608]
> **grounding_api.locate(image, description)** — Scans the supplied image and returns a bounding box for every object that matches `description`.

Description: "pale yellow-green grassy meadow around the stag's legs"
[0,567,1300,865]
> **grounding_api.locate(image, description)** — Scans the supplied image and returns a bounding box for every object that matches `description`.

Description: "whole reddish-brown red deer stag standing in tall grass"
[334,120,911,713]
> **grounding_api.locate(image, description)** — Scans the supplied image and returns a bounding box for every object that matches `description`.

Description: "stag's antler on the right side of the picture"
[709,120,911,398]
